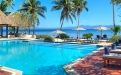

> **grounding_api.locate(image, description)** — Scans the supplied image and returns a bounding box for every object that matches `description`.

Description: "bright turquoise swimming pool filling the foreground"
[0,40,99,75]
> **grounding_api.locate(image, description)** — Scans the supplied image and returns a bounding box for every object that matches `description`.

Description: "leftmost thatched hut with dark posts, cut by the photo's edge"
[0,10,14,37]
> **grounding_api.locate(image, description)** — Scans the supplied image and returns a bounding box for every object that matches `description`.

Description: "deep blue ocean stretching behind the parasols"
[4,29,114,39]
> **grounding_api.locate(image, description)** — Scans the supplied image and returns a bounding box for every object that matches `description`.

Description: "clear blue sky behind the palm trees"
[7,0,121,28]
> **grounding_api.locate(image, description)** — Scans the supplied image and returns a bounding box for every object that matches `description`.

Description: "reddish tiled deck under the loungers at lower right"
[73,50,121,75]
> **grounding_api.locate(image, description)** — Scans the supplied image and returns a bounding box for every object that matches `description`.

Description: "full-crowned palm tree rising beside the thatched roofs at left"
[19,0,47,35]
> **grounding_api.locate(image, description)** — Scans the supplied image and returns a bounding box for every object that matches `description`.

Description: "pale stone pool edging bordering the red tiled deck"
[63,47,104,75]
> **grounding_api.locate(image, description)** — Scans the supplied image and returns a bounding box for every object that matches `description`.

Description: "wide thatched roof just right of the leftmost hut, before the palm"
[8,12,32,33]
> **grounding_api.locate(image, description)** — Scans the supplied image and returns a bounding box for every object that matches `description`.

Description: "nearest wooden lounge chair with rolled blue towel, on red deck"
[102,47,121,67]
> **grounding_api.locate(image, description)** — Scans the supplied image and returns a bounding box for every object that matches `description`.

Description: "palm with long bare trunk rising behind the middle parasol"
[73,0,88,38]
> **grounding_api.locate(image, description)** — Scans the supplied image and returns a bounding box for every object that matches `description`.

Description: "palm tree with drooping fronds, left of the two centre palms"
[51,0,75,30]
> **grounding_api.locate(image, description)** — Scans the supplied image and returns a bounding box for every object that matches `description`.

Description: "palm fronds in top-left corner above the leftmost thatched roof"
[0,0,14,13]
